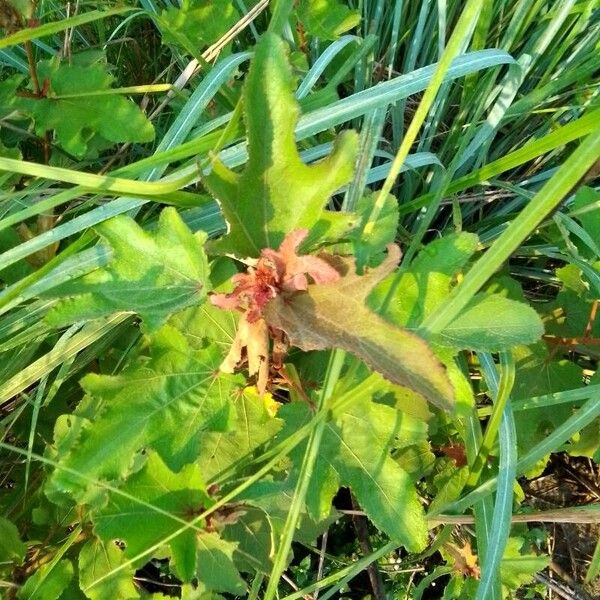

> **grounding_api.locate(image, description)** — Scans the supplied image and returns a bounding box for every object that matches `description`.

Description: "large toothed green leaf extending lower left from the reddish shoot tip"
[47,327,237,498]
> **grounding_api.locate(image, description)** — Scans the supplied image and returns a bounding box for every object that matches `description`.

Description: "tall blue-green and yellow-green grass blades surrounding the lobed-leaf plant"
[0,0,600,600]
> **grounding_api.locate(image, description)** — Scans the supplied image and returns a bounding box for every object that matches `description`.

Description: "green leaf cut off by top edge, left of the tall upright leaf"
[157,0,239,56]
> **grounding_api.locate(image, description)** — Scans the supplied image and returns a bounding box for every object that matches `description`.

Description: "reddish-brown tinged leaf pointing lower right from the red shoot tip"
[265,246,454,410]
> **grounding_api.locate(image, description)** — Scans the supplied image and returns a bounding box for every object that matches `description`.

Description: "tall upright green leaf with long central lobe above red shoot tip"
[203,33,357,257]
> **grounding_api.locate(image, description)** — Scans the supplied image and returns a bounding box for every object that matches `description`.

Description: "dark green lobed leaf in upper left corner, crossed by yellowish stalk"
[15,63,154,158]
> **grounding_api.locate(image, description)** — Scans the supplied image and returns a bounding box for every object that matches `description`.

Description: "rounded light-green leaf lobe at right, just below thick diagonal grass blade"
[435,294,544,352]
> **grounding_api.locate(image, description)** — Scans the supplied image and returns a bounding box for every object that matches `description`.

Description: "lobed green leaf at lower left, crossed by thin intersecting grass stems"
[92,452,212,581]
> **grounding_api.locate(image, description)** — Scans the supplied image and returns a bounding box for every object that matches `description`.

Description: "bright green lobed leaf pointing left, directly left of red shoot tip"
[46,208,209,331]
